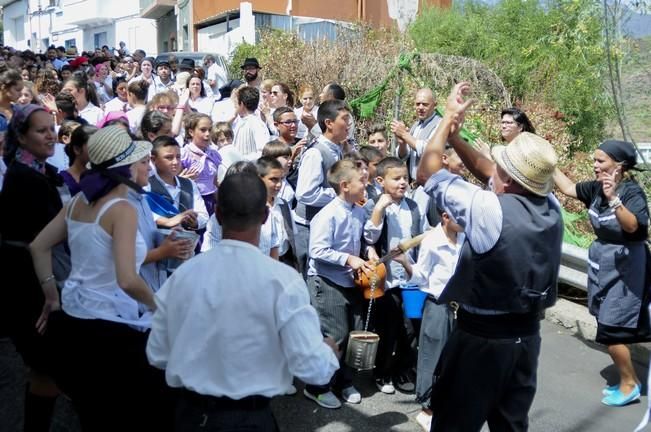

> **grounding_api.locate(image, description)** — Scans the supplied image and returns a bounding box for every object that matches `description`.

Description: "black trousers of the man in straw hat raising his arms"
[431,316,540,432]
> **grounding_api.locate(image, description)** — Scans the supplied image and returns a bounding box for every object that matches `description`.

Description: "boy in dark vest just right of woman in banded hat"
[149,136,208,230]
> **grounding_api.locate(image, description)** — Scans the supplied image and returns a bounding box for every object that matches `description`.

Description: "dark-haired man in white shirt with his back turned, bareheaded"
[147,172,339,432]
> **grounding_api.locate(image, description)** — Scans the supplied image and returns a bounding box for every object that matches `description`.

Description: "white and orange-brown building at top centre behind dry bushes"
[140,0,452,56]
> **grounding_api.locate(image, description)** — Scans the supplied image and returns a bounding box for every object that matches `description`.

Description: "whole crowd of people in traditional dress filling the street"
[0,40,651,431]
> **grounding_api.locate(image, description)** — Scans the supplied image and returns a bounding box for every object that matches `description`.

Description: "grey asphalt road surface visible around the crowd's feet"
[53,321,651,432]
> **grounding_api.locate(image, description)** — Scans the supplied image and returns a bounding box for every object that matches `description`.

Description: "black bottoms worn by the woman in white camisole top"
[48,312,176,432]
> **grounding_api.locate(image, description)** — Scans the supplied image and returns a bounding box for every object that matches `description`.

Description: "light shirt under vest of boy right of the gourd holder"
[364,199,429,289]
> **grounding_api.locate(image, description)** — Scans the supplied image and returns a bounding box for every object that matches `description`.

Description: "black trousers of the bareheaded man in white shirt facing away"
[174,390,279,432]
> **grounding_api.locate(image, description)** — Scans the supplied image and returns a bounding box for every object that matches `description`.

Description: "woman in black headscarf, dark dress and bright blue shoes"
[554,140,649,406]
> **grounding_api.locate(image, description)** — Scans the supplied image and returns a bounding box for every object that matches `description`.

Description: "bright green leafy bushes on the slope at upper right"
[410,0,612,152]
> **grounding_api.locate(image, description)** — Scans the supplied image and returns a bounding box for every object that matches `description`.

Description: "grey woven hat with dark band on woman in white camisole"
[88,126,151,169]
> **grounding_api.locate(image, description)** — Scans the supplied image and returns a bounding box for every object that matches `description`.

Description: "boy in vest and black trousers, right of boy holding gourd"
[364,157,429,394]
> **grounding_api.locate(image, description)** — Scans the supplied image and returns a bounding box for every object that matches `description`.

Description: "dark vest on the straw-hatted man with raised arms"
[439,194,563,313]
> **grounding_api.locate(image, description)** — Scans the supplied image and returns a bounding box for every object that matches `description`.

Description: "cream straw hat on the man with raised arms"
[491,132,558,196]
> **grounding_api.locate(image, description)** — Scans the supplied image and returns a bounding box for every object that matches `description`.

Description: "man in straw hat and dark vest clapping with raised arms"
[418,83,563,432]
